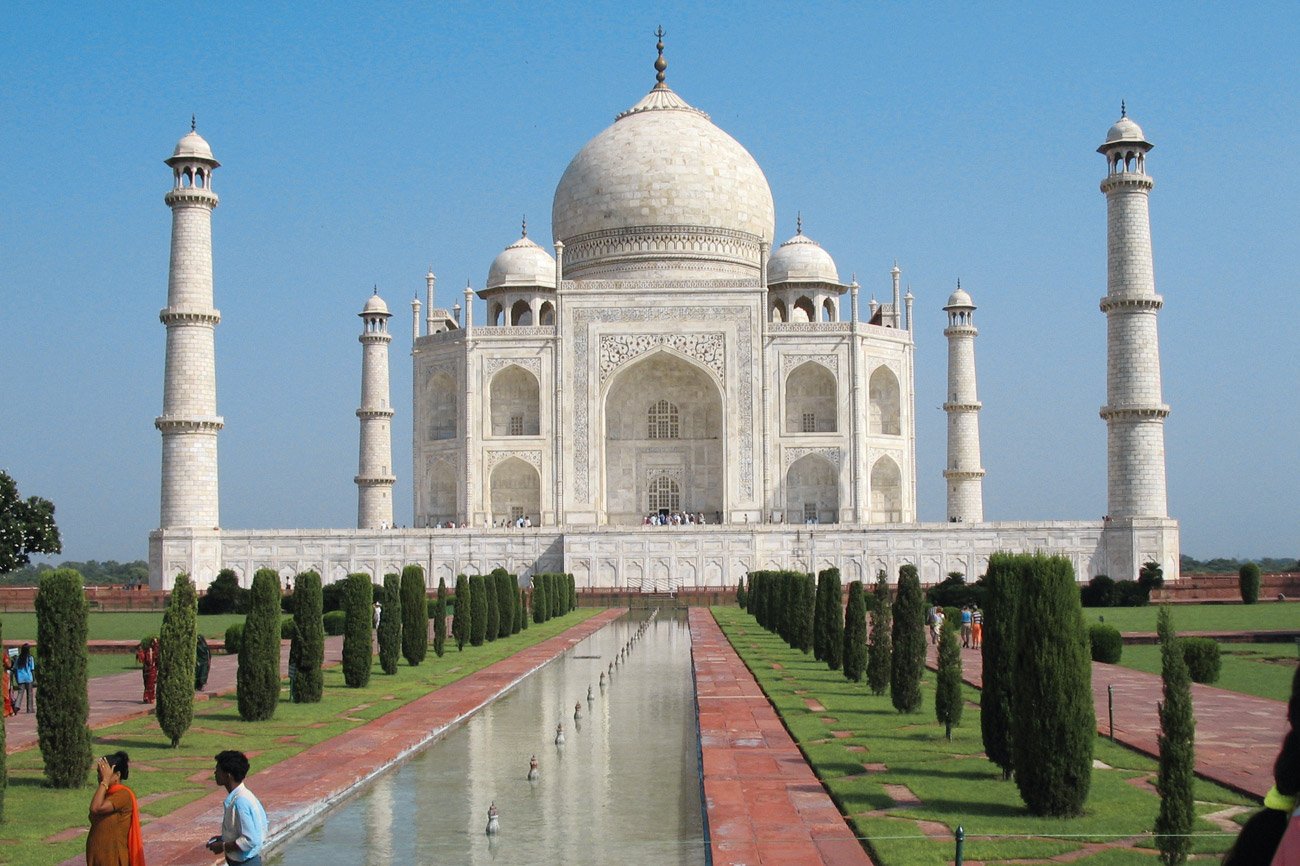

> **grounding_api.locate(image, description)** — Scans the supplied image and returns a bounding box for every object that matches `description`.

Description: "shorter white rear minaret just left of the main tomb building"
[356,289,397,529]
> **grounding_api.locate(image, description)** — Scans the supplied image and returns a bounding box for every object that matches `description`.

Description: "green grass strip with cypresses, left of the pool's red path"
[0,607,601,866]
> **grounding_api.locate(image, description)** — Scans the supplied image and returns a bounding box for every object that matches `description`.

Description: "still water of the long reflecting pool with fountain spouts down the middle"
[268,611,706,866]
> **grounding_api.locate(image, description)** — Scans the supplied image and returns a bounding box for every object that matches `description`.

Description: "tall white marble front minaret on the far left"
[153,118,224,529]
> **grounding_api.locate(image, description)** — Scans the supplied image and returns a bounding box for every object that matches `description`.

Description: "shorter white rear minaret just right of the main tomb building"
[944,281,984,523]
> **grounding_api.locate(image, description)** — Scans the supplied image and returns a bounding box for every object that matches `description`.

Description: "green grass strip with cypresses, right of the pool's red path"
[714,607,1251,866]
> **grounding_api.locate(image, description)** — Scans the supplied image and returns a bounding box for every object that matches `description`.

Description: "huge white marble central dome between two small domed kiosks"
[551,83,774,280]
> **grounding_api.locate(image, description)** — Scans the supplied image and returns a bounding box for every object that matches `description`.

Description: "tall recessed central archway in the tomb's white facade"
[603,350,727,525]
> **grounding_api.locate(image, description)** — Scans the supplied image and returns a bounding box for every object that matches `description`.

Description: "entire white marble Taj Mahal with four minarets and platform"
[150,43,1178,588]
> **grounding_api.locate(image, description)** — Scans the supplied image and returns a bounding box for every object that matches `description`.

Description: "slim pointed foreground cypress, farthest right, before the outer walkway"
[1156,605,1196,866]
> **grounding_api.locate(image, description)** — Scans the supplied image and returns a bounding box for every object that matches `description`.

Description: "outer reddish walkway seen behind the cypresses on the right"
[928,634,1287,800]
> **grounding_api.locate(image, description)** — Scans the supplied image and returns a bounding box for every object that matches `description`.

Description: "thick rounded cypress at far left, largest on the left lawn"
[34,568,92,788]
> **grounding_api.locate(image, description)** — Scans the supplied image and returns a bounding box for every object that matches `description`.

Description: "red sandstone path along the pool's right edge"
[689,607,871,866]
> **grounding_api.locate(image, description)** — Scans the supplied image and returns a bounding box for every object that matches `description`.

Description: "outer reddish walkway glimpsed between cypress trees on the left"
[5,636,343,753]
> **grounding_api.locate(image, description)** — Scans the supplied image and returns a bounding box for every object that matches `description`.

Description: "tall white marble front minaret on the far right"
[1097,107,1169,519]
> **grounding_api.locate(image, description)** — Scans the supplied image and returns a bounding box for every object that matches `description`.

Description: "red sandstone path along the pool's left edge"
[113,610,625,866]
